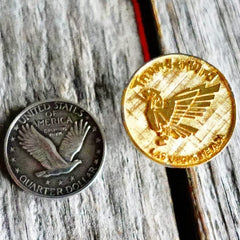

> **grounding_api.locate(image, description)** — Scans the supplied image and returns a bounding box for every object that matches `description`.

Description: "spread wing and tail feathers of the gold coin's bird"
[168,84,220,138]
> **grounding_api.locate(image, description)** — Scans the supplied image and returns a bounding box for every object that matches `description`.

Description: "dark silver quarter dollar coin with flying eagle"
[4,100,105,198]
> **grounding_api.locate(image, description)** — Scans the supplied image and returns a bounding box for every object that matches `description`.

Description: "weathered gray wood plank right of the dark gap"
[152,0,240,240]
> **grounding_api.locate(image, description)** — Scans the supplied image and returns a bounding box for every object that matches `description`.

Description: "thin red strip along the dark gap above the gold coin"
[132,0,151,62]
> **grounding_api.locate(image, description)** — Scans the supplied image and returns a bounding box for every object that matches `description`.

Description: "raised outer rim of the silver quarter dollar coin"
[4,98,107,199]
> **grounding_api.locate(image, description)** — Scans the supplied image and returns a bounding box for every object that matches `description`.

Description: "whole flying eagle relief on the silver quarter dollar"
[18,119,91,178]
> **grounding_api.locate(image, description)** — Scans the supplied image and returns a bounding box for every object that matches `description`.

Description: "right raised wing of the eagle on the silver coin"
[59,119,91,161]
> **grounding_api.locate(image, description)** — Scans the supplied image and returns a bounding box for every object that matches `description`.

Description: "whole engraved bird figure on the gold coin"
[143,84,220,146]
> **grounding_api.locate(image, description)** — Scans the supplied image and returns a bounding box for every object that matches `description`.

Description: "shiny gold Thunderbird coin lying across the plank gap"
[122,54,236,167]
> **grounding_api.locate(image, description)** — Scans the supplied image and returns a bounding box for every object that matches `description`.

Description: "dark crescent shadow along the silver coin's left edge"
[0,108,23,179]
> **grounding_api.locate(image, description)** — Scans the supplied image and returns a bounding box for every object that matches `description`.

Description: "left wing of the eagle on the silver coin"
[18,124,67,169]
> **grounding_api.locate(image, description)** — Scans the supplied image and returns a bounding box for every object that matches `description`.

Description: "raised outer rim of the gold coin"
[121,53,236,168]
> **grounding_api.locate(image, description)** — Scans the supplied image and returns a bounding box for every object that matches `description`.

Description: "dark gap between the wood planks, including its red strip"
[132,0,200,240]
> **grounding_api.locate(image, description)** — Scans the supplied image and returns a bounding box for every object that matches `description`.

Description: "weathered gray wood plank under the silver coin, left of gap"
[0,0,180,240]
